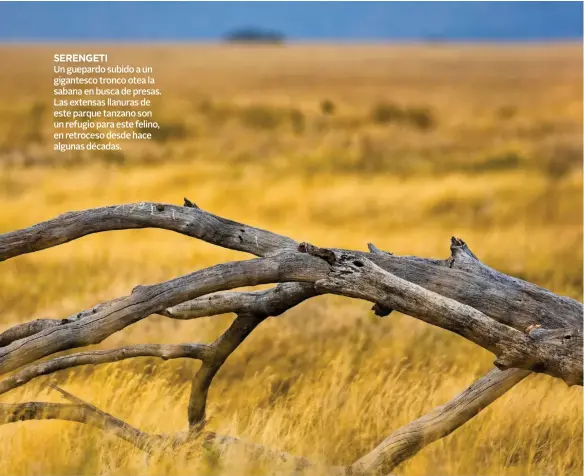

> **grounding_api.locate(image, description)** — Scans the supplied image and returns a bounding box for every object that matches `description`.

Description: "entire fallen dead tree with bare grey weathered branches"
[0,199,583,475]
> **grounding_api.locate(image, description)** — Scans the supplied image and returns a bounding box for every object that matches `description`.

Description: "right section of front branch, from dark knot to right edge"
[301,243,583,385]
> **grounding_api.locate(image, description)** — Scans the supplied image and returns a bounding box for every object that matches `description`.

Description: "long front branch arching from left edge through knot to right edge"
[0,244,582,385]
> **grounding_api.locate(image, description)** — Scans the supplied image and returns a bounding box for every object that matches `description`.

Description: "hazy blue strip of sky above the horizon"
[0,2,582,42]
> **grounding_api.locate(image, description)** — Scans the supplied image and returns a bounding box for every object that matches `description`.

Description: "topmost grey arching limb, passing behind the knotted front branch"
[0,202,583,330]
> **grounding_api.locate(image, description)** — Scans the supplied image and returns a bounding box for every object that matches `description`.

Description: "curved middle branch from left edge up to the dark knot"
[0,252,328,374]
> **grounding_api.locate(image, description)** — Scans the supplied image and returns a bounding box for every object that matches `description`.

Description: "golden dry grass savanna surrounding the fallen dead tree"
[0,44,583,476]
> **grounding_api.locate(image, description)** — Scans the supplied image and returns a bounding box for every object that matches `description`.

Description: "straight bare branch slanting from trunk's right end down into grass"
[347,368,530,476]
